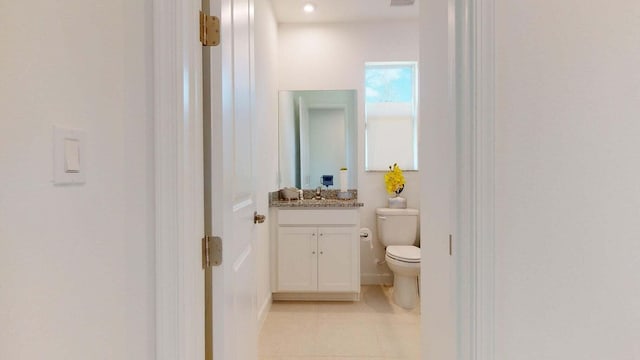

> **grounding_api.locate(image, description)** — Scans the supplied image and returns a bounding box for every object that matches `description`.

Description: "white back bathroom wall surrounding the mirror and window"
[278,21,420,284]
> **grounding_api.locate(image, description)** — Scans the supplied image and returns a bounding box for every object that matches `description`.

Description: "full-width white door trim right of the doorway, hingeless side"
[456,0,495,360]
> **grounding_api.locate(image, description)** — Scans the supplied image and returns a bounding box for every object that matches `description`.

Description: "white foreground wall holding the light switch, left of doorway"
[0,0,155,359]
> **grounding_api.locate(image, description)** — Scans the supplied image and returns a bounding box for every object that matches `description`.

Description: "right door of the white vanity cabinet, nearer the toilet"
[318,226,360,292]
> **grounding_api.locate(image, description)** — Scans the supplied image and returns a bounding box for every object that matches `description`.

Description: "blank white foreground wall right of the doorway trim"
[495,0,640,360]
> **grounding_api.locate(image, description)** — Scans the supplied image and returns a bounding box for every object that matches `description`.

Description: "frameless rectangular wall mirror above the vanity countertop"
[278,90,358,189]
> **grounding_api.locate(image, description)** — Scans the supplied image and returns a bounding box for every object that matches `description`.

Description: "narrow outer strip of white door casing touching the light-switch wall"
[153,0,182,360]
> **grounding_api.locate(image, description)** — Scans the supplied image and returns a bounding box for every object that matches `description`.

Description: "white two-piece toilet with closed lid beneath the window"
[376,208,420,309]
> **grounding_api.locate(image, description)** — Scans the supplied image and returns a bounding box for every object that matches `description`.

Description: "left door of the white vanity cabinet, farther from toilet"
[277,226,318,291]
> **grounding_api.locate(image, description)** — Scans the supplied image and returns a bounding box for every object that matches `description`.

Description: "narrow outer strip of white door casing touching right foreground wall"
[473,0,495,360]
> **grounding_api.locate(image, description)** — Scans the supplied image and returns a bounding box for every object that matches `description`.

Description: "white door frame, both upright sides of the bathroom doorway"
[153,0,495,360]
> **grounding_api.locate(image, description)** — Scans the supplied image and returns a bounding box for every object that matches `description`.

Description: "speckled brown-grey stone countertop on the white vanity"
[269,190,364,208]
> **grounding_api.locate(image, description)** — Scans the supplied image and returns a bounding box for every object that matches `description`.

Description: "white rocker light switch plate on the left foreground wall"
[53,126,87,185]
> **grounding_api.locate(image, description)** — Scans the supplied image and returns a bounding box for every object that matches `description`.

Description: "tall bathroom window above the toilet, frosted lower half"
[365,62,418,171]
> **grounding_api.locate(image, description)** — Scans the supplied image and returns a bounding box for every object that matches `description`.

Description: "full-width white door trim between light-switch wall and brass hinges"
[153,0,204,360]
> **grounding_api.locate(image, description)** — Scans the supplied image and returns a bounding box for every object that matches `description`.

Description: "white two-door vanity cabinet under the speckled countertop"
[274,208,360,300]
